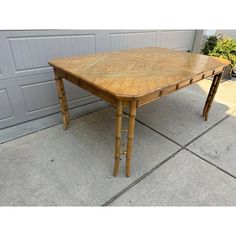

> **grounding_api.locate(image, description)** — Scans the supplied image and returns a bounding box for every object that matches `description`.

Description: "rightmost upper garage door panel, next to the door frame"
[161,30,195,51]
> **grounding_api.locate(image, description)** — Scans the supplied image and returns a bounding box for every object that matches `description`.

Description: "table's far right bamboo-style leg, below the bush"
[203,73,222,121]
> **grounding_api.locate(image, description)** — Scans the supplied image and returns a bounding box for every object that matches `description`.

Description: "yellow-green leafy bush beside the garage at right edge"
[202,35,236,74]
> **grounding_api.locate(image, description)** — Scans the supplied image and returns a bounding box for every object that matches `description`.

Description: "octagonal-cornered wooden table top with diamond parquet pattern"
[49,47,229,98]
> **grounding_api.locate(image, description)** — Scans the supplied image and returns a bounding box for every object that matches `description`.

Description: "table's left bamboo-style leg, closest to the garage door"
[56,77,69,129]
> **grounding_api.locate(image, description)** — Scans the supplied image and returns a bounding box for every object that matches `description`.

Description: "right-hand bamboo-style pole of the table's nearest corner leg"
[126,101,136,177]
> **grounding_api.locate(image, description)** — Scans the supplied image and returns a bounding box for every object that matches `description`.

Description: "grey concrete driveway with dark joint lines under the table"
[0,80,236,206]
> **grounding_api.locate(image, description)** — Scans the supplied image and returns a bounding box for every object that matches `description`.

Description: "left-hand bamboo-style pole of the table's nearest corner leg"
[113,100,123,176]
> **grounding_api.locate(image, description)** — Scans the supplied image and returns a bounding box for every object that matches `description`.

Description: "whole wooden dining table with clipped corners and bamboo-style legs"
[49,47,229,176]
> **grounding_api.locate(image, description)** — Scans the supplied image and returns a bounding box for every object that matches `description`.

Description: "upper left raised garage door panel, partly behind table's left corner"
[9,35,95,71]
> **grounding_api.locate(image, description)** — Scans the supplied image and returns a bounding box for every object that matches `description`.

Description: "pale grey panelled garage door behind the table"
[0,30,195,128]
